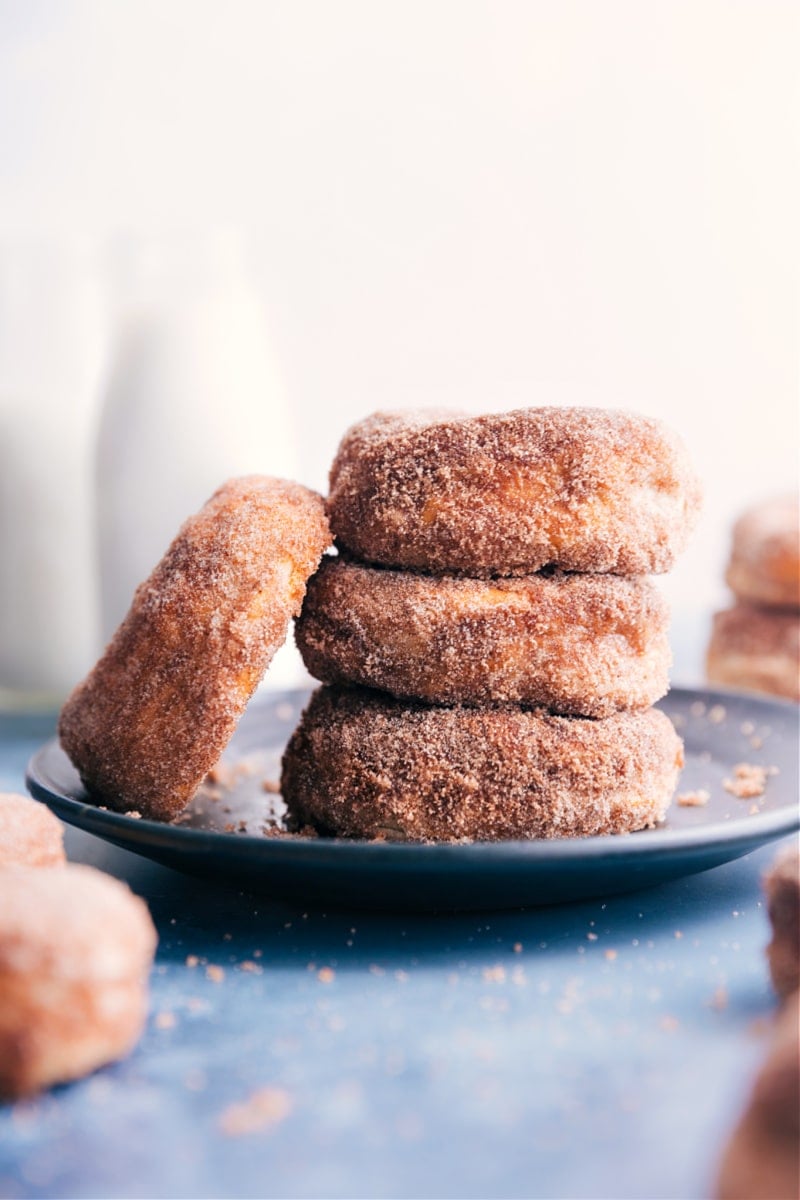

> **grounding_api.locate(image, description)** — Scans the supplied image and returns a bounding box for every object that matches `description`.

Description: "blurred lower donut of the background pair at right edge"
[705,602,800,700]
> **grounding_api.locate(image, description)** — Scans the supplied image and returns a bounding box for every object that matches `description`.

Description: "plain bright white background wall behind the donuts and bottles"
[0,0,800,681]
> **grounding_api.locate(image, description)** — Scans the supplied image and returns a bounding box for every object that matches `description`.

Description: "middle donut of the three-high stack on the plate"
[295,558,670,716]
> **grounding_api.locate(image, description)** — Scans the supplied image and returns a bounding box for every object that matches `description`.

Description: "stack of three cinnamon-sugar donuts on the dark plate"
[282,408,699,840]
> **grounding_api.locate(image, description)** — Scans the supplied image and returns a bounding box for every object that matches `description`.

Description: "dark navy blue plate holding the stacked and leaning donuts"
[26,688,800,911]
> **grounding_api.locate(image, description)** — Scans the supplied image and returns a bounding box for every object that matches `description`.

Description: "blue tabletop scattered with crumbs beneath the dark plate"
[0,700,791,1200]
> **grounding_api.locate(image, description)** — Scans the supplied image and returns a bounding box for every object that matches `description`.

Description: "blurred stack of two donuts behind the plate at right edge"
[706,496,800,700]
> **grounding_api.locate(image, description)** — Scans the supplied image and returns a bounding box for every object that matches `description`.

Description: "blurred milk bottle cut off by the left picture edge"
[0,236,106,709]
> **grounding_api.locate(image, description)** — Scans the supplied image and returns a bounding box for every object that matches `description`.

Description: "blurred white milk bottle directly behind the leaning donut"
[97,234,296,681]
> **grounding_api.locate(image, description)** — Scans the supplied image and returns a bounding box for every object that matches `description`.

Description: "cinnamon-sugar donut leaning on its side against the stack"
[59,475,330,821]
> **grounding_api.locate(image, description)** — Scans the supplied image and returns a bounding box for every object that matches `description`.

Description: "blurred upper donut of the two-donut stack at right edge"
[726,496,800,608]
